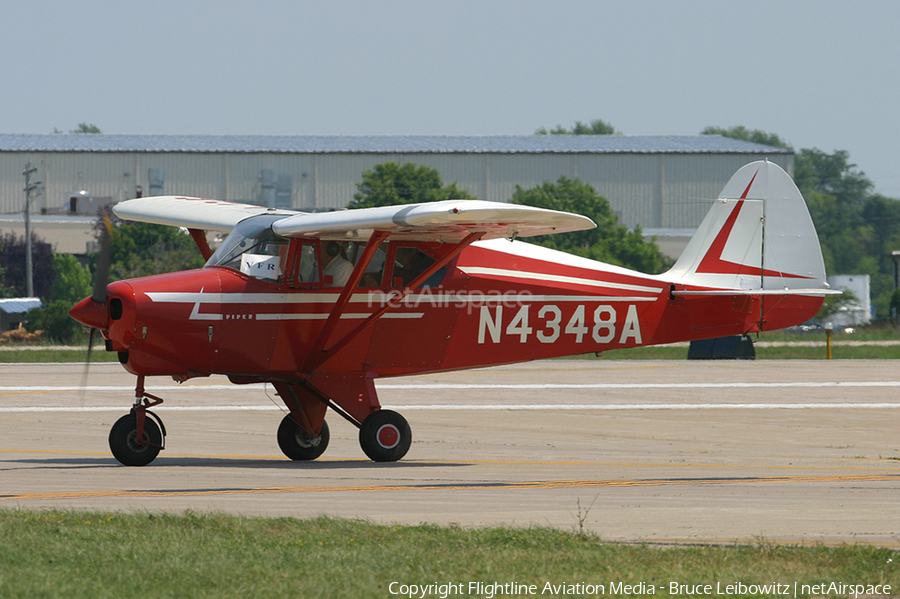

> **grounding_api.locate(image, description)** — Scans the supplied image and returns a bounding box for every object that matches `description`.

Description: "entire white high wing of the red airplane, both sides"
[113,196,597,243]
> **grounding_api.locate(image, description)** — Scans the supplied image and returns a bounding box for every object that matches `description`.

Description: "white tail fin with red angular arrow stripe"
[666,161,827,293]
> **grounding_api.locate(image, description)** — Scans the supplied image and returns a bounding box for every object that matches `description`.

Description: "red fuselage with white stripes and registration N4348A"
[73,240,822,380]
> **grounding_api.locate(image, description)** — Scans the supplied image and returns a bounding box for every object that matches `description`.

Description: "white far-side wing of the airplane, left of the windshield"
[113,196,297,233]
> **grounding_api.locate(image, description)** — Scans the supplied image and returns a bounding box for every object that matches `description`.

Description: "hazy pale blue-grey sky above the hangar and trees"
[0,0,900,198]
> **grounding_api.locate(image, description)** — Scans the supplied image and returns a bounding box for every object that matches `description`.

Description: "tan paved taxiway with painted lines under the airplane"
[0,360,900,548]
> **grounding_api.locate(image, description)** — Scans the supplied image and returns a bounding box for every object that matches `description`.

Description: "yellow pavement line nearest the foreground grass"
[0,474,900,501]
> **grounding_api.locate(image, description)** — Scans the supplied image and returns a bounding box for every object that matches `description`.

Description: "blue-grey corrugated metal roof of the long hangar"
[0,134,793,154]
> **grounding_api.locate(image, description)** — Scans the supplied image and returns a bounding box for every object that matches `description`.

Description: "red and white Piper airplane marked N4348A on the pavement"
[70,162,833,466]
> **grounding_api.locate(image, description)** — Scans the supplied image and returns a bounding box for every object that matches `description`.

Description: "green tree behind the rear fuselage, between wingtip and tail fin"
[510,177,672,274]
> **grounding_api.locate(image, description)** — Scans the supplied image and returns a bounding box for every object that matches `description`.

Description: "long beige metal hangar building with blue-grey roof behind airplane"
[0,134,794,254]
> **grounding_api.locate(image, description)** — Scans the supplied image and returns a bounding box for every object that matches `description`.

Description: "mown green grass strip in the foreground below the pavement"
[0,510,900,599]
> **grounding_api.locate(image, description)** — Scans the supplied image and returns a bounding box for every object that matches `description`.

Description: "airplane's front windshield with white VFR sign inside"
[206,215,290,282]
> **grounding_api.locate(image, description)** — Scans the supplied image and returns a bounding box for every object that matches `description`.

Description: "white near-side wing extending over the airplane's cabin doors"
[272,200,597,243]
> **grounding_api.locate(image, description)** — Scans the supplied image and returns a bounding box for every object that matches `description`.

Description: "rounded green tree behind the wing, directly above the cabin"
[348,162,475,208]
